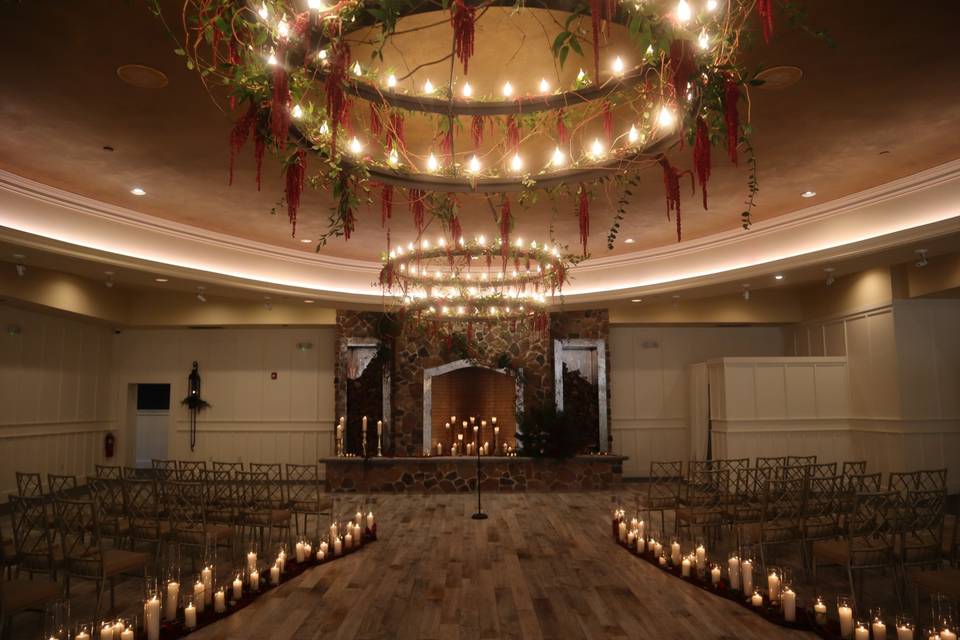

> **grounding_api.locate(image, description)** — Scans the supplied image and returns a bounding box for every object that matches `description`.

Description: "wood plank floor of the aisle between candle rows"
[190,492,813,640]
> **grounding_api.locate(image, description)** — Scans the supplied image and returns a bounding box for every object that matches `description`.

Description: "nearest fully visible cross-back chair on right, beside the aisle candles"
[813,491,902,611]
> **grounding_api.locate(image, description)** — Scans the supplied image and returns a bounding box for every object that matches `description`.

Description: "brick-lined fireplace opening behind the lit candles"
[422,360,523,455]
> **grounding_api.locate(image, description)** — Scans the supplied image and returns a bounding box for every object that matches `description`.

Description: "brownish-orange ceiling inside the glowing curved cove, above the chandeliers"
[0,0,960,260]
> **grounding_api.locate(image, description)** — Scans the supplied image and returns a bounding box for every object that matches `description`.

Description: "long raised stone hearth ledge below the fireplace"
[320,455,626,493]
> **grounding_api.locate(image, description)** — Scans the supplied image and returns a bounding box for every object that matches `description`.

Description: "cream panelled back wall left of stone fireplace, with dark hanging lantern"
[114,327,335,464]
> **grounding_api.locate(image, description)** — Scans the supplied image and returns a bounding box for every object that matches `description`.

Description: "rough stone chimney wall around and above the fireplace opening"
[335,309,610,456]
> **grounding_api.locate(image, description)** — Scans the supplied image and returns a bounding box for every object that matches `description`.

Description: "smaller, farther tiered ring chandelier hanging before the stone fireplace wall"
[380,235,573,323]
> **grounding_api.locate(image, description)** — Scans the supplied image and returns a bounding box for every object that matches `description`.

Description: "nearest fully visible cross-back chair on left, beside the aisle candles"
[53,496,150,621]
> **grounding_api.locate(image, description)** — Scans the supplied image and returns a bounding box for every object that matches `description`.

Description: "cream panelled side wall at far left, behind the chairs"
[0,304,113,496]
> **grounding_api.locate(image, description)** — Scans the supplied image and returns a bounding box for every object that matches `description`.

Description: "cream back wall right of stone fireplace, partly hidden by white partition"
[610,326,783,477]
